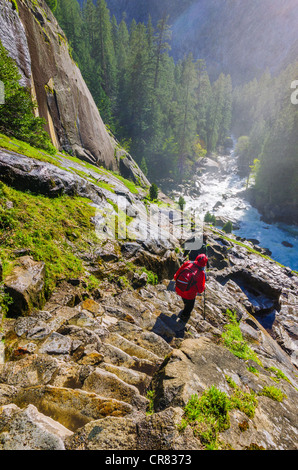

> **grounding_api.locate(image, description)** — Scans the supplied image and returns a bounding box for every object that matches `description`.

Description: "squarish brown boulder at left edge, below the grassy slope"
[4,256,45,316]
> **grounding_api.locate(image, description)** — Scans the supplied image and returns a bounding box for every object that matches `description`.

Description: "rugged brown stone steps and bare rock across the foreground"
[0,226,298,450]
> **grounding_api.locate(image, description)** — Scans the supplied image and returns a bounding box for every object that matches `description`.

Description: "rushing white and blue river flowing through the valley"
[176,151,298,271]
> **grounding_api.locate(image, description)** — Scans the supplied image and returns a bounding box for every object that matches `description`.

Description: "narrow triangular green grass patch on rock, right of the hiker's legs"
[221,309,262,365]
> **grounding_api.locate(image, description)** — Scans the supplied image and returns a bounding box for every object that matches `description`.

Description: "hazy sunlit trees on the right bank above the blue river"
[232,62,298,221]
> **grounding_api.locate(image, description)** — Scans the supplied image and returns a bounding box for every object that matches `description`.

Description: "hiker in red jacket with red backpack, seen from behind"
[174,254,208,322]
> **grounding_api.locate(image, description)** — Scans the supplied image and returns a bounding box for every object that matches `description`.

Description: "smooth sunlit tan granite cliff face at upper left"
[18,0,116,169]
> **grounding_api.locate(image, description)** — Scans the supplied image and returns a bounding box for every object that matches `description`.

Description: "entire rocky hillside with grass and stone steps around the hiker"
[0,144,298,451]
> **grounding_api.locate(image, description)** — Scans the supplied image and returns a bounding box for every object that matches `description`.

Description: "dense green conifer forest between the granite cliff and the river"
[55,0,232,181]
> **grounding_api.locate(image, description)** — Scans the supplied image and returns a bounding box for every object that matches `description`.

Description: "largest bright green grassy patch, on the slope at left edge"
[0,183,96,295]
